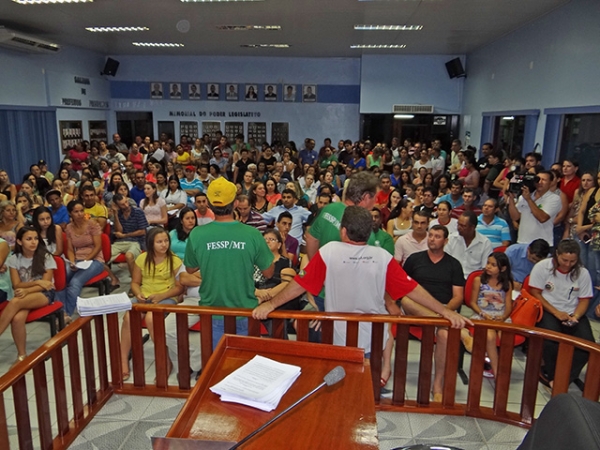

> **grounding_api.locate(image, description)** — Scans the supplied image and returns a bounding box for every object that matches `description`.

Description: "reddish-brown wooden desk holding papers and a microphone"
[167,335,378,450]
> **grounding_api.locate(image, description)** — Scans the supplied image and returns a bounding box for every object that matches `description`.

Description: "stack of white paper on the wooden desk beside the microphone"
[210,355,300,412]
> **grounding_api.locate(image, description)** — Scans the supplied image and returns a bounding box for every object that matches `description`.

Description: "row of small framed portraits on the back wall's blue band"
[150,82,317,103]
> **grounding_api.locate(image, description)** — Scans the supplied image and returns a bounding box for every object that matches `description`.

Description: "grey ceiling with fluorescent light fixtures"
[0,0,569,57]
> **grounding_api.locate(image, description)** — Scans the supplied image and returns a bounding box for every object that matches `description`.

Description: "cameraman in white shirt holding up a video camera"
[508,171,562,246]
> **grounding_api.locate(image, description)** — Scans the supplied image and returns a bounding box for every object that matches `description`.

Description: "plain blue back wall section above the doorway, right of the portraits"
[360,55,465,114]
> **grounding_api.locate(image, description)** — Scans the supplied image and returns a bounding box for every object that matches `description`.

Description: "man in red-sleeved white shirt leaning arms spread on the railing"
[252,206,470,352]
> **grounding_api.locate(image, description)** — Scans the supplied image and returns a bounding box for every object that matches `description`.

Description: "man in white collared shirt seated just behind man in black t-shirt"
[445,211,494,279]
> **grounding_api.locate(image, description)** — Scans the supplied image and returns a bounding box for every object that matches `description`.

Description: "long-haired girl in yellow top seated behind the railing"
[121,227,184,381]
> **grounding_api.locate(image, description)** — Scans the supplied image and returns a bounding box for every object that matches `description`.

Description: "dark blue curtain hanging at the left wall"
[0,109,60,184]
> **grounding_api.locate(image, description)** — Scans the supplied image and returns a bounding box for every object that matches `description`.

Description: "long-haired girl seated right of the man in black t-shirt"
[461,252,513,375]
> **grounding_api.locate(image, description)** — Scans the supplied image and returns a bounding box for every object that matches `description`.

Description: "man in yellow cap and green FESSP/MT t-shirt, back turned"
[165,177,274,368]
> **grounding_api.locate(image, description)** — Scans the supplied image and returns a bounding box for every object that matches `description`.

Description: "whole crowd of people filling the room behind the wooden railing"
[0,132,600,401]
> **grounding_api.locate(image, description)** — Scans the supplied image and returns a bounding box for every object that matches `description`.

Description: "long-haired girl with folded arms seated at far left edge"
[0,226,56,363]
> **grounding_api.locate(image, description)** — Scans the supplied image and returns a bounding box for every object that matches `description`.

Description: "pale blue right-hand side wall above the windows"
[462,0,600,155]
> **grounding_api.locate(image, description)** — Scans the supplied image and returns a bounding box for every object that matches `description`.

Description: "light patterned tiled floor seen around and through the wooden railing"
[0,267,600,450]
